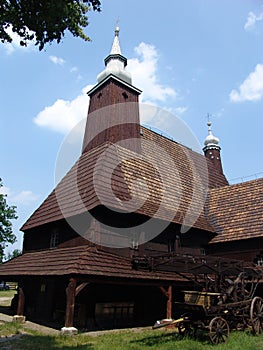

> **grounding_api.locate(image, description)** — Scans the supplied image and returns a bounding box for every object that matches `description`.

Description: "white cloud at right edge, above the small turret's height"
[229,64,263,102]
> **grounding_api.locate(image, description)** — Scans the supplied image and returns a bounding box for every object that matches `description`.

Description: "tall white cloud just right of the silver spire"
[127,42,176,101]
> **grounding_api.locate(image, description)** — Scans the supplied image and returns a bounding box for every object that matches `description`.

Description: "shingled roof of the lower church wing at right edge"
[207,178,263,243]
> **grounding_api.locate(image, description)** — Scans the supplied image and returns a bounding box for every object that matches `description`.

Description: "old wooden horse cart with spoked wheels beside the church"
[132,254,263,344]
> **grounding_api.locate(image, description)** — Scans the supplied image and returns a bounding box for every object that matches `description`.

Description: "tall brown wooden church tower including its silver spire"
[82,26,141,153]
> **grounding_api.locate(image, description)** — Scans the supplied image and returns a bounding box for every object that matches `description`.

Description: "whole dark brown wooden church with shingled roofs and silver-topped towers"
[0,27,263,330]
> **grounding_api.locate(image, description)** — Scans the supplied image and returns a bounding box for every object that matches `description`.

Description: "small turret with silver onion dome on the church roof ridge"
[203,121,223,174]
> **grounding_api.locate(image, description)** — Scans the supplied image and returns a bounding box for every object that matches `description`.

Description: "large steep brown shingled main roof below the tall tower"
[22,127,228,232]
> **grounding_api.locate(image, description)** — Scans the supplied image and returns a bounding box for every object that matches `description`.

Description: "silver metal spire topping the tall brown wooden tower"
[97,26,132,85]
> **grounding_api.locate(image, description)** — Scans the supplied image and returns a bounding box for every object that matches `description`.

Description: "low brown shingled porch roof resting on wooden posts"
[0,246,186,281]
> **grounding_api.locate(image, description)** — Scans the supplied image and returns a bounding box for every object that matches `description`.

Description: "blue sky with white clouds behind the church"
[0,0,263,256]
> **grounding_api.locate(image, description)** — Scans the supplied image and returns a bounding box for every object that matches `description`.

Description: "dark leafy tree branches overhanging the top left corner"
[0,0,101,50]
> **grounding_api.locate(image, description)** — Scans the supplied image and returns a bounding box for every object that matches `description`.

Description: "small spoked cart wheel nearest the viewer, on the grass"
[209,317,229,344]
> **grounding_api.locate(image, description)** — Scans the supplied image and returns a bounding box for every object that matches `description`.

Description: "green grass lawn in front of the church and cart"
[0,323,263,350]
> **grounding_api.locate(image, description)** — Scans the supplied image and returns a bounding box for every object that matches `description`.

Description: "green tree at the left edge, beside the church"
[0,179,17,262]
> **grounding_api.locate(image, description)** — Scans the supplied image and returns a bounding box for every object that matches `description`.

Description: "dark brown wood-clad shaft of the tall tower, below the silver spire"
[83,79,140,153]
